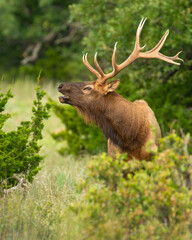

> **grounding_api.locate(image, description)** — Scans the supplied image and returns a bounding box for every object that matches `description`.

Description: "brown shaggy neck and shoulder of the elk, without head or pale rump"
[78,92,149,152]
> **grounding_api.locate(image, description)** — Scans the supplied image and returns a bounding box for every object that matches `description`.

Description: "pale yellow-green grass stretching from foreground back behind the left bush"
[0,79,89,240]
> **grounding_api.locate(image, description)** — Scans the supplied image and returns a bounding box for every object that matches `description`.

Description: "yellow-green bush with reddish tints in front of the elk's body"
[71,133,192,240]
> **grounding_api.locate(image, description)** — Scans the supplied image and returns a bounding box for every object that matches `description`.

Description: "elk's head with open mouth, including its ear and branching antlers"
[58,18,183,109]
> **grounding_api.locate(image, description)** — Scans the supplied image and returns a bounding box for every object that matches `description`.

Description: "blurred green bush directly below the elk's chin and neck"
[50,100,107,155]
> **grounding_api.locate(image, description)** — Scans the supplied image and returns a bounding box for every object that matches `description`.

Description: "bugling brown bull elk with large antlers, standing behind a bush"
[58,18,183,160]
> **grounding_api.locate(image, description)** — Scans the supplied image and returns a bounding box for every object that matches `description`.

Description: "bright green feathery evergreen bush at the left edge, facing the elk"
[0,87,50,188]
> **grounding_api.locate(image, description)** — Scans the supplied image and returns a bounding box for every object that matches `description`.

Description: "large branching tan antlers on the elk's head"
[83,18,183,84]
